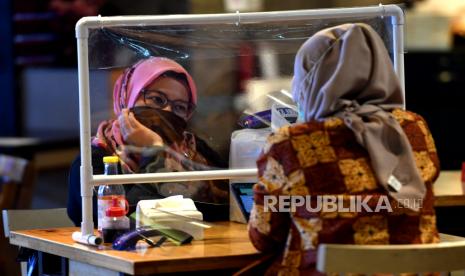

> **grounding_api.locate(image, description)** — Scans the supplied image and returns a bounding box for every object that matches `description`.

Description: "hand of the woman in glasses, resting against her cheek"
[118,109,163,147]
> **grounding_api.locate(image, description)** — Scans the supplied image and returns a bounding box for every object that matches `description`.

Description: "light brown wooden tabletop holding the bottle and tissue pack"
[10,222,260,274]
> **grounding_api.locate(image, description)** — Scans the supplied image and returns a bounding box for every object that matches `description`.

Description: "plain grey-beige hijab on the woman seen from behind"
[292,23,426,210]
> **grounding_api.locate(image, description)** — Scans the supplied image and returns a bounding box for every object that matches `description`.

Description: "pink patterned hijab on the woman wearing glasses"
[92,57,197,172]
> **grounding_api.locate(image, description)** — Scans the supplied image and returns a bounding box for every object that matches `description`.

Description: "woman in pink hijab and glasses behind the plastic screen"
[68,57,227,225]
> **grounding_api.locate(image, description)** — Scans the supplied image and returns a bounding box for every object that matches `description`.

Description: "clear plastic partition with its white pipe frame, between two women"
[77,5,403,235]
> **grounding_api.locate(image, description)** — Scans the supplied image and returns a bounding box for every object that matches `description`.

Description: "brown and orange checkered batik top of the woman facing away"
[249,109,439,275]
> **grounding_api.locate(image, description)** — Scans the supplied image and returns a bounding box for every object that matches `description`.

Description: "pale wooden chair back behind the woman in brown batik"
[317,234,465,274]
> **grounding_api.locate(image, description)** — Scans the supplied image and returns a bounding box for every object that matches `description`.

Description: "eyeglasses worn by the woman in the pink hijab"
[142,89,195,118]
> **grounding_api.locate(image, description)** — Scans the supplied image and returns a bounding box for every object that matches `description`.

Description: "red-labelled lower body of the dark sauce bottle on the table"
[102,198,129,243]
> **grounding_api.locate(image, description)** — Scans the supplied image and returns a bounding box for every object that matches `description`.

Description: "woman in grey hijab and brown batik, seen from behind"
[249,23,440,275]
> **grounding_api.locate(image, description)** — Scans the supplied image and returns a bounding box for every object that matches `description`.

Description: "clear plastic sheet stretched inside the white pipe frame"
[82,9,393,207]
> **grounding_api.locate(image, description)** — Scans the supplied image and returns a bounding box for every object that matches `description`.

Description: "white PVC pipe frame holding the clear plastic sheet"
[76,5,405,235]
